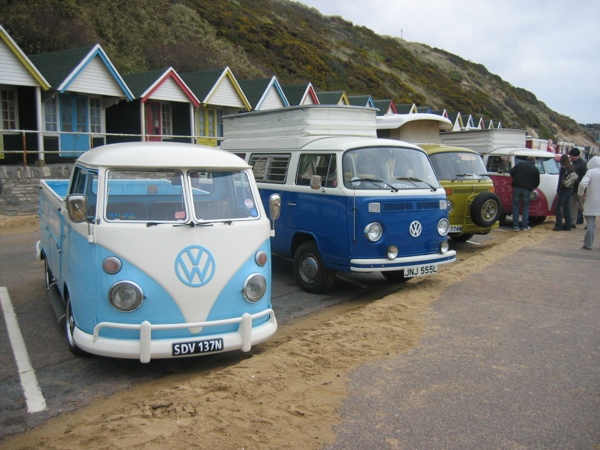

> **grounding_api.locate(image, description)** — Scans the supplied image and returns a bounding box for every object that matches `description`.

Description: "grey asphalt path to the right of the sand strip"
[327,227,600,450]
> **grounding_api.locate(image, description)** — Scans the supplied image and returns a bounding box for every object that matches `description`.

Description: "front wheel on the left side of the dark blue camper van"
[294,241,335,294]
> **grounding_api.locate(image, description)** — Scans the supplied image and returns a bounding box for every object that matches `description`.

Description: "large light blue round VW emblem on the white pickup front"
[175,245,216,287]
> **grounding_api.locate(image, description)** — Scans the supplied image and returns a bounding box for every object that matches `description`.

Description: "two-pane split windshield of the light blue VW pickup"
[105,170,258,224]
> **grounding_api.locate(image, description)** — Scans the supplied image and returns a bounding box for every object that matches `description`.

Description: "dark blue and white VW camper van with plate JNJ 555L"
[222,106,456,293]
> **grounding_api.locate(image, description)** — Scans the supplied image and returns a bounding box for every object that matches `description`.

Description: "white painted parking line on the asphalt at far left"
[0,286,46,413]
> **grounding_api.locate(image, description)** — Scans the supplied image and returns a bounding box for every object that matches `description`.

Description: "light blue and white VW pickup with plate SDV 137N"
[37,143,278,362]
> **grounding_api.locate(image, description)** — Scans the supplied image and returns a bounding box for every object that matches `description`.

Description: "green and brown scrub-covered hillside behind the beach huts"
[0,0,592,145]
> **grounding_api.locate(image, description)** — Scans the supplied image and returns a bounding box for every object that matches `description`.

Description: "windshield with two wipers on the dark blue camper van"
[342,147,439,190]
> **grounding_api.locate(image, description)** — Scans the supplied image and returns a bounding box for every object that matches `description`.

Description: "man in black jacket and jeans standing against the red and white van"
[510,156,540,231]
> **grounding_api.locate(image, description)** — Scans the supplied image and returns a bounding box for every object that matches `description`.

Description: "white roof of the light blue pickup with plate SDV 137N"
[77,142,249,170]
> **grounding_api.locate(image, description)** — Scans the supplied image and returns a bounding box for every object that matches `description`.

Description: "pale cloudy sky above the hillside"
[295,0,600,124]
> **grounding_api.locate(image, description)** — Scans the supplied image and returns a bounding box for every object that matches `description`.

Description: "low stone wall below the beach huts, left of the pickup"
[0,164,73,216]
